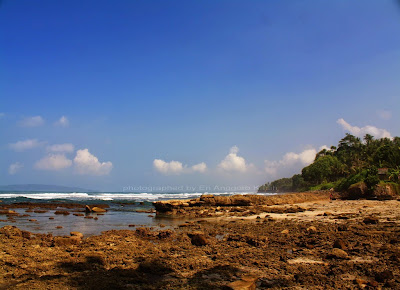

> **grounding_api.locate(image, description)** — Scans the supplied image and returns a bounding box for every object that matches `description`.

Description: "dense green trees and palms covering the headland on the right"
[259,134,400,192]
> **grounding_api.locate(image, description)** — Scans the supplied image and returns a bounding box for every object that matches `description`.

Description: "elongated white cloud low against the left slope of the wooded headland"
[264,145,322,177]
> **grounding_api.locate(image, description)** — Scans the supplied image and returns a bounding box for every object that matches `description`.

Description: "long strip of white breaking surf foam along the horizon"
[0,192,275,201]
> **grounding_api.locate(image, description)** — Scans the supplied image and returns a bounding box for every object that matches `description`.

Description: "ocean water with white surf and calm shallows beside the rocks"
[0,192,273,236]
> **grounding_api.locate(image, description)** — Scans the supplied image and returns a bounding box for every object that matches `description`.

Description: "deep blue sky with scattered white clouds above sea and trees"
[0,0,400,191]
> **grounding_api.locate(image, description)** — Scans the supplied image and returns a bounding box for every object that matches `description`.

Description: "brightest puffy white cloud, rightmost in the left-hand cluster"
[74,149,113,175]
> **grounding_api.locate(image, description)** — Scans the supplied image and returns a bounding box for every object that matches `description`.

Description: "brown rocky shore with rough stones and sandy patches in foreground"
[0,193,400,289]
